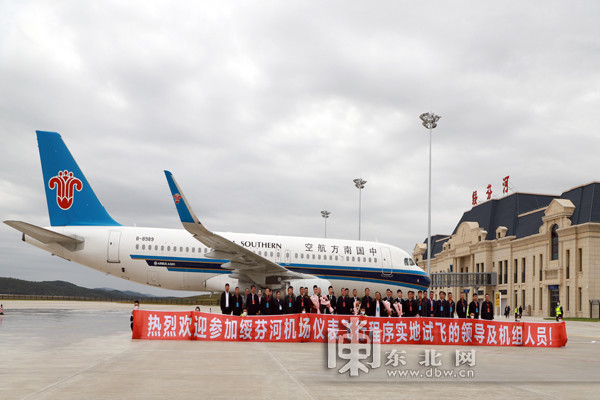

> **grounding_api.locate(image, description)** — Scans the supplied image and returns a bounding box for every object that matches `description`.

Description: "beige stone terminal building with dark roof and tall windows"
[413,182,600,318]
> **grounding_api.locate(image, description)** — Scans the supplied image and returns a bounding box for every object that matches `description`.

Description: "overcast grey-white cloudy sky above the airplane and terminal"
[0,0,600,294]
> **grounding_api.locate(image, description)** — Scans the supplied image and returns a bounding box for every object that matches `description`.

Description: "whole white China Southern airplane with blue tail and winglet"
[4,131,430,296]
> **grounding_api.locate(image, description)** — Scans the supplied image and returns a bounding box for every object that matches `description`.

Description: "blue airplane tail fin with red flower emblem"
[36,131,120,226]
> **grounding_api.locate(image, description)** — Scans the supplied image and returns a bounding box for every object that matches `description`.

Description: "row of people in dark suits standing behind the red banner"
[219,284,494,320]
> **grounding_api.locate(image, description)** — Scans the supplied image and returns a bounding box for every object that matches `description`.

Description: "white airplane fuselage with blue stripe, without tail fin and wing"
[25,226,429,294]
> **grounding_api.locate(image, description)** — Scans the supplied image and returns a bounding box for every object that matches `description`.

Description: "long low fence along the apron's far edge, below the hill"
[0,294,219,306]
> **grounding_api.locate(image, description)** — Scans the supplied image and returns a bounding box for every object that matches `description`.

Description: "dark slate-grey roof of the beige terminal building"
[424,182,600,259]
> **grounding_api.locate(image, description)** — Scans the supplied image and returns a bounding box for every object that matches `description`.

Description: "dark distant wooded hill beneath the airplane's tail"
[0,278,151,298]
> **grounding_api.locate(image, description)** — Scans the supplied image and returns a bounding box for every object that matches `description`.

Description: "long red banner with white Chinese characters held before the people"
[132,310,567,347]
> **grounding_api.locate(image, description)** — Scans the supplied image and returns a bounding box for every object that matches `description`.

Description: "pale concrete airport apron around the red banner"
[0,300,600,399]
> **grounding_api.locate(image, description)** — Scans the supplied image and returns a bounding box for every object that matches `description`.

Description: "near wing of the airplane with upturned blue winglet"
[165,171,301,278]
